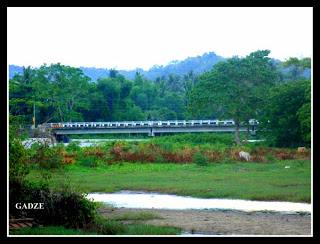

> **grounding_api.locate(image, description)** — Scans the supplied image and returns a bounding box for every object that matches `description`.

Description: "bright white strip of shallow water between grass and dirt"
[87,191,311,213]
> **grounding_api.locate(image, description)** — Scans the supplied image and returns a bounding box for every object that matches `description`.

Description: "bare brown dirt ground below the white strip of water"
[100,208,311,235]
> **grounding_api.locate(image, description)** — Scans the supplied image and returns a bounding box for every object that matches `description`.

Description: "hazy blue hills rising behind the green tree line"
[9,52,224,81]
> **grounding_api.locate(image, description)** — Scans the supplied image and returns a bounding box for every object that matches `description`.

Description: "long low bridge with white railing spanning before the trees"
[44,120,259,141]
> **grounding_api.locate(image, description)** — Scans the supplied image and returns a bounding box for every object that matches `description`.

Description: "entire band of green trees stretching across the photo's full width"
[9,50,311,146]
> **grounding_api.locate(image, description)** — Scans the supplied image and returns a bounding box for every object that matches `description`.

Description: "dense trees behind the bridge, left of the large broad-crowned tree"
[9,64,190,124]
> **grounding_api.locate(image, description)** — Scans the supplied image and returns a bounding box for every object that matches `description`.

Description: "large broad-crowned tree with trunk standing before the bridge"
[189,50,278,145]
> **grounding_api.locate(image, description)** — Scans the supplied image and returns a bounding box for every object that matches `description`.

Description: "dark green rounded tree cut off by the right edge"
[261,80,311,147]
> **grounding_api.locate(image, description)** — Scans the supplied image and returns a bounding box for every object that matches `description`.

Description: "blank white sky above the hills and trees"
[7,7,313,70]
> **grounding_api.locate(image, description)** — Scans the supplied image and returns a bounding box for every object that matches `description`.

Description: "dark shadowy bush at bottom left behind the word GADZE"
[9,181,97,228]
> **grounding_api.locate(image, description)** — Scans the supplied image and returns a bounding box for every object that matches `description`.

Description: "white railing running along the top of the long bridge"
[45,119,259,129]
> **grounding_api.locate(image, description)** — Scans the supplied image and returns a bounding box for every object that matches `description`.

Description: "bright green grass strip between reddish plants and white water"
[28,160,311,202]
